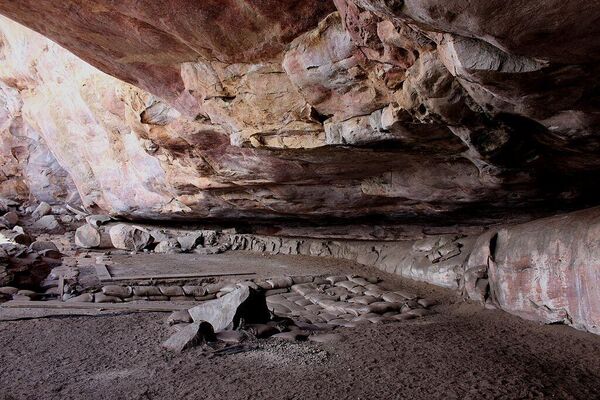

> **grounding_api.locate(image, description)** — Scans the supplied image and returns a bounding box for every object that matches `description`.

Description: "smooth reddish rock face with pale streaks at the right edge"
[488,209,600,333]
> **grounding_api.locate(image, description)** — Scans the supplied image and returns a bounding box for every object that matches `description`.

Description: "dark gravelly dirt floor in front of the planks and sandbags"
[0,255,600,399]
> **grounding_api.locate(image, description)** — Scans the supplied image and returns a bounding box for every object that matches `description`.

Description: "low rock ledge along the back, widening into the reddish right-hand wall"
[221,207,600,334]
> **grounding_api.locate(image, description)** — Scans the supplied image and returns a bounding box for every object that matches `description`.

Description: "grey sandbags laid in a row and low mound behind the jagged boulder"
[61,275,435,327]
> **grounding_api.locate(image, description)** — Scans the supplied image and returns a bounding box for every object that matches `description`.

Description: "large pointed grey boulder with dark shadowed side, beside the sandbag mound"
[189,287,270,332]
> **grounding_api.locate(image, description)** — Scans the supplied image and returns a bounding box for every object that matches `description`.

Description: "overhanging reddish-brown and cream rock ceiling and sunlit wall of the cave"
[0,0,600,223]
